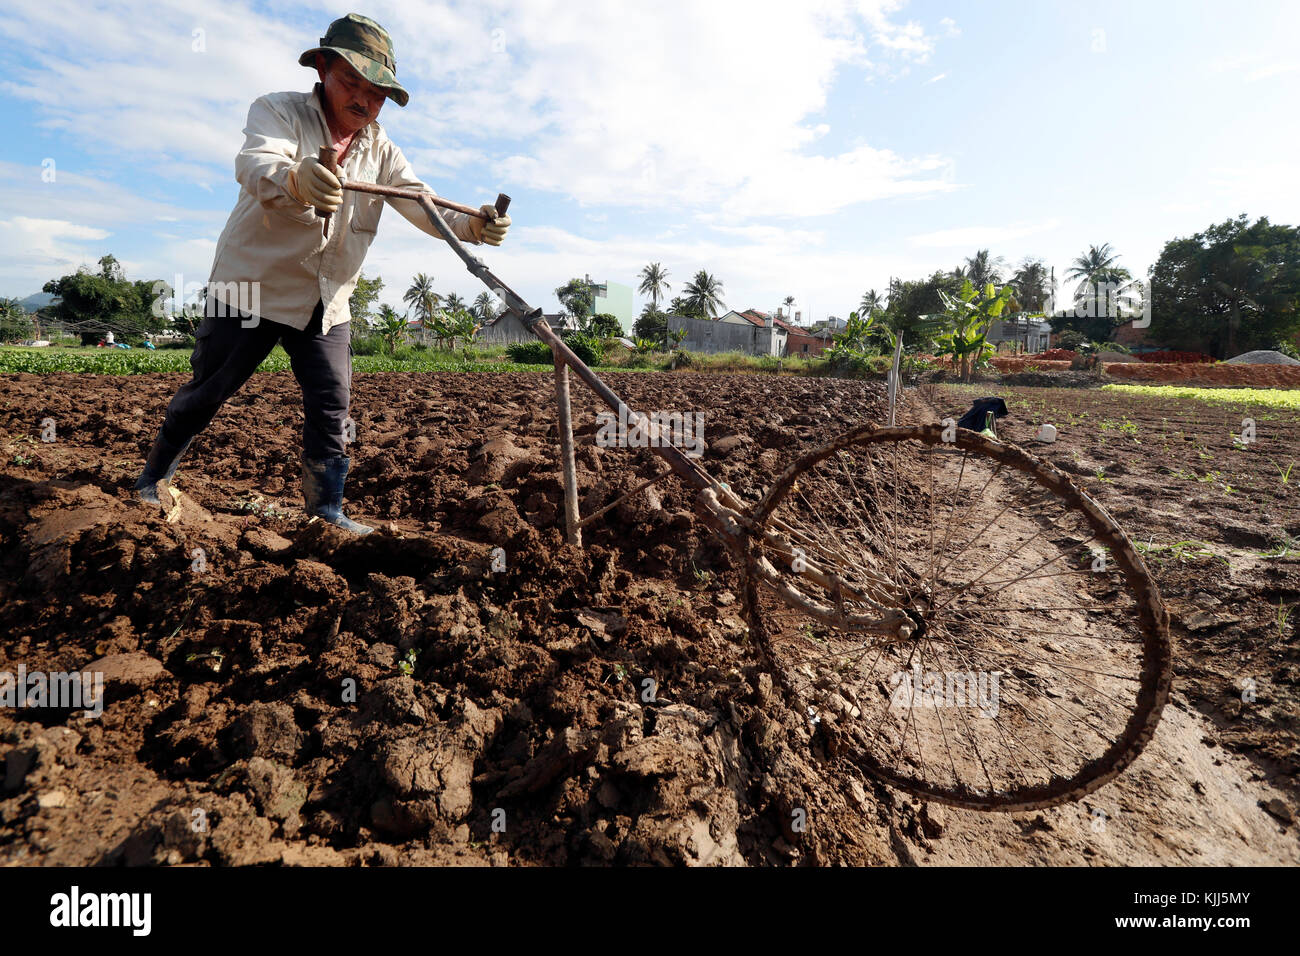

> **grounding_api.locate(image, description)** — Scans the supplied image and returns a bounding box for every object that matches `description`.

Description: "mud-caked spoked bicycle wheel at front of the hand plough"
[745,425,1171,810]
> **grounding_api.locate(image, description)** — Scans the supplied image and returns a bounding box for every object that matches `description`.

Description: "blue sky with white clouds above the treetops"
[0,0,1300,325]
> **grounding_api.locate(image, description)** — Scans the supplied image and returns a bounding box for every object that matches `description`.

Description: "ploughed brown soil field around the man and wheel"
[0,372,1300,865]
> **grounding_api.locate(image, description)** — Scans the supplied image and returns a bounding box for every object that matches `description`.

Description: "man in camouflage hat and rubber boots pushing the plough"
[135,13,510,535]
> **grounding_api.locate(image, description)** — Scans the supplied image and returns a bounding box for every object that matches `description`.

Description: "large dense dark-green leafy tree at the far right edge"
[1151,213,1300,358]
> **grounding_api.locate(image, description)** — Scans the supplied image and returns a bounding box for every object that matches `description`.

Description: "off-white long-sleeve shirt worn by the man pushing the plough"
[208,83,475,332]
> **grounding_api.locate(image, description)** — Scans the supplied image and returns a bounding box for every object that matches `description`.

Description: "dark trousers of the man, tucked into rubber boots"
[159,299,352,459]
